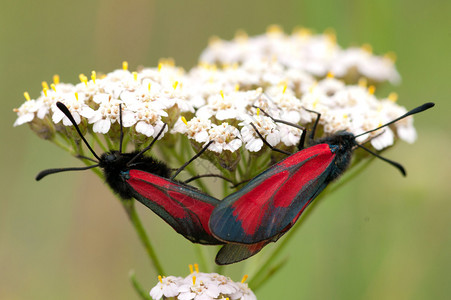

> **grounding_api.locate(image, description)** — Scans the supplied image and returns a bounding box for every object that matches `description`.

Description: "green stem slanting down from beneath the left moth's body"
[121,200,166,275]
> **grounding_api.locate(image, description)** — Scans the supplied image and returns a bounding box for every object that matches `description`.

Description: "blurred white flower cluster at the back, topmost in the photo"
[200,26,400,83]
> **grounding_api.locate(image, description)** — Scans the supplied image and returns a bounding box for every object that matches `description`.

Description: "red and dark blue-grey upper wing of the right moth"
[209,144,335,244]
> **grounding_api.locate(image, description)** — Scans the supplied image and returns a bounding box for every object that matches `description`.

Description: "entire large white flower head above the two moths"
[14,30,416,153]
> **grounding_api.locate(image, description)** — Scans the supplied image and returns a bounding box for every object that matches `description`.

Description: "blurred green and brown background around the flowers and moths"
[0,0,451,299]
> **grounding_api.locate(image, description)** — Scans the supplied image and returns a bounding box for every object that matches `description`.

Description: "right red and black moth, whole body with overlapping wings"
[209,103,434,264]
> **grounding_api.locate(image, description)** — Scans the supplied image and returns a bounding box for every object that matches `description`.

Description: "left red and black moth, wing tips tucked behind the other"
[36,102,223,245]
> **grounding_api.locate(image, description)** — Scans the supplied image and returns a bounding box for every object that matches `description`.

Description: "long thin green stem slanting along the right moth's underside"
[249,158,372,291]
